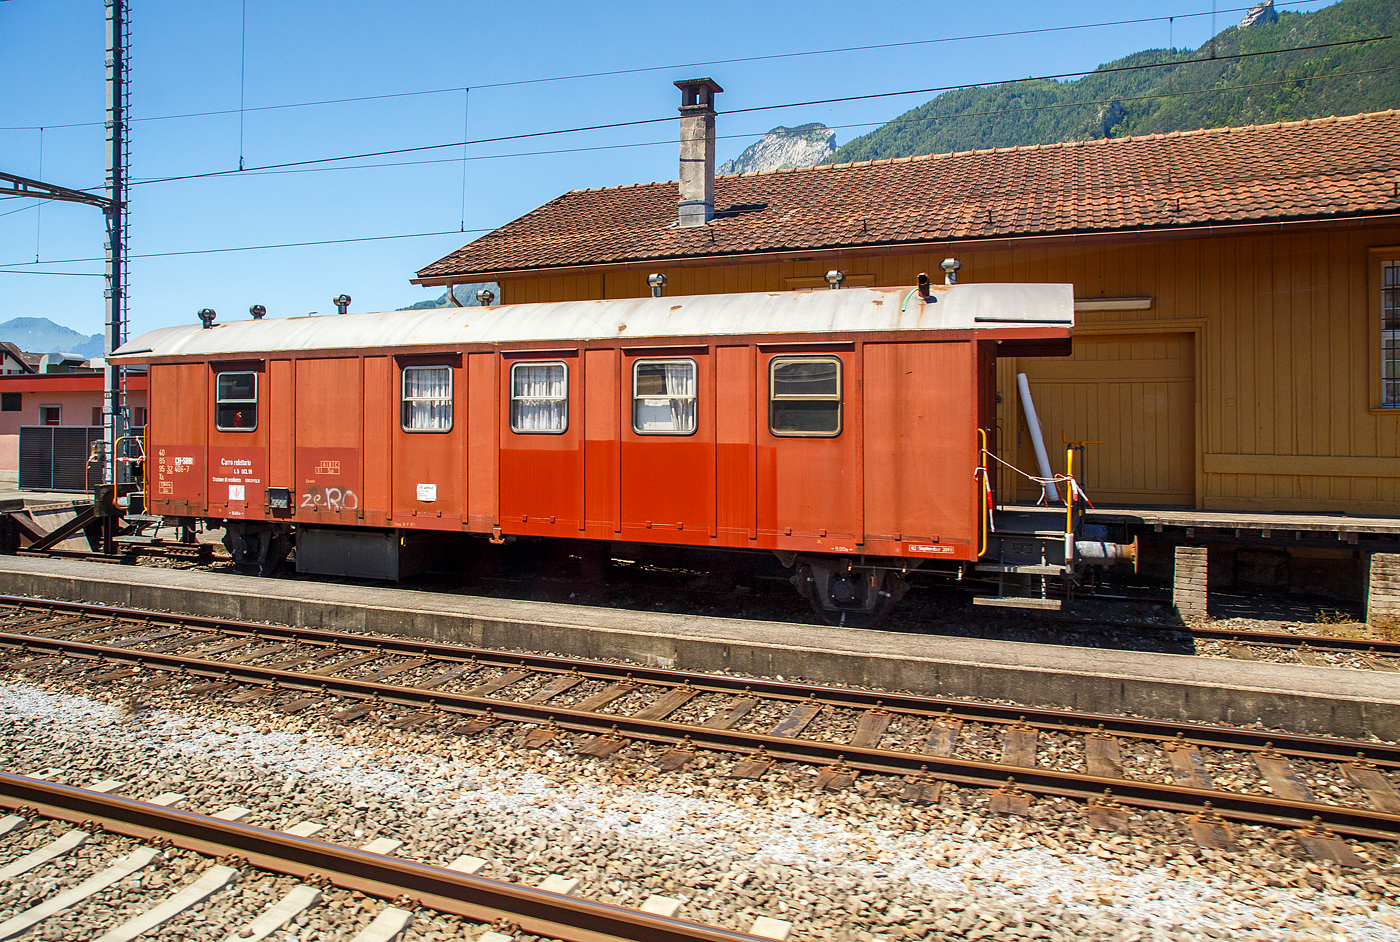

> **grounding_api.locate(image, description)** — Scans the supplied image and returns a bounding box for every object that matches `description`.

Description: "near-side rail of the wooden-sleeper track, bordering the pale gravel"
[0,633,1400,840]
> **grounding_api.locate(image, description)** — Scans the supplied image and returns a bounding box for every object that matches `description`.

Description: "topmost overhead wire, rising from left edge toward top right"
[0,0,1327,130]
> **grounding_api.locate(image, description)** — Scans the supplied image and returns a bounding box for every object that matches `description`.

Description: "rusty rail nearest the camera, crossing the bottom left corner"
[0,773,757,942]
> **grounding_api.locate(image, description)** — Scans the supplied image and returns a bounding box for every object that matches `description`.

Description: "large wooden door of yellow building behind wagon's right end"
[1002,333,1196,505]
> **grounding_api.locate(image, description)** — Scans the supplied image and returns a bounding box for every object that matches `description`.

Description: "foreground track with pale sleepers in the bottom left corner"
[0,773,760,942]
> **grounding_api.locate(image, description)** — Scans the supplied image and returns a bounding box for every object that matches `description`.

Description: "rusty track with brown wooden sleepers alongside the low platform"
[0,598,1400,864]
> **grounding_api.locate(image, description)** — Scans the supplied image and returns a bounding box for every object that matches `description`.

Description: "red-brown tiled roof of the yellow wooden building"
[419,111,1400,281]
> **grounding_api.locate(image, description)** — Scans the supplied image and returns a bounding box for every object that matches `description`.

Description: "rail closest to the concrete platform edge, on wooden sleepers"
[0,595,1400,768]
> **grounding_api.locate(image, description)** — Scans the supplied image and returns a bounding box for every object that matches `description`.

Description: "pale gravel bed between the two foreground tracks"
[0,676,1400,942]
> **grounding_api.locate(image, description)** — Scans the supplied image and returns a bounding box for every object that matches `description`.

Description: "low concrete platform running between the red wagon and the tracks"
[0,557,1400,742]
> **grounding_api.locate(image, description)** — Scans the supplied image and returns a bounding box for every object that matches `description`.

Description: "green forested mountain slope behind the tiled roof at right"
[823,0,1400,164]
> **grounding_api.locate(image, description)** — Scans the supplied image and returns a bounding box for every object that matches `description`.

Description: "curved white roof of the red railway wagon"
[112,284,1074,361]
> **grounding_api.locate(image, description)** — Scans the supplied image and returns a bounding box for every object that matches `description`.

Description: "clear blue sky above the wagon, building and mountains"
[0,0,1327,336]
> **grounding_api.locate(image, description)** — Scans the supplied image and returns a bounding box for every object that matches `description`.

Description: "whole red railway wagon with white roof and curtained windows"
[115,284,1074,621]
